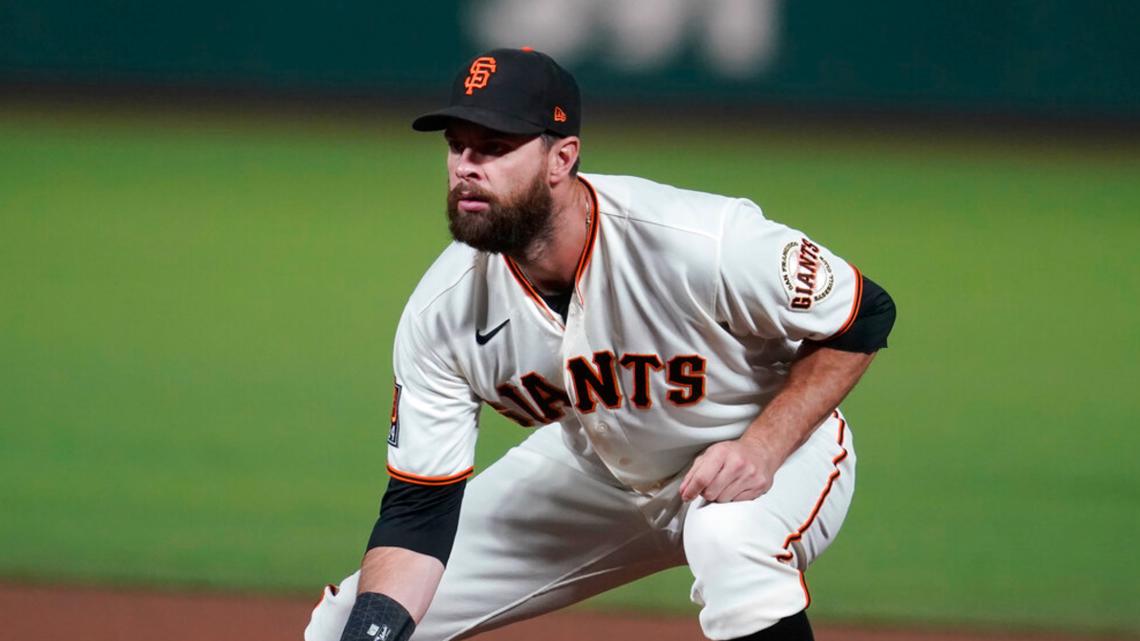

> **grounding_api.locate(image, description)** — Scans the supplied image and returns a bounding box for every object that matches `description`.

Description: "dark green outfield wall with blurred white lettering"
[0,0,1140,117]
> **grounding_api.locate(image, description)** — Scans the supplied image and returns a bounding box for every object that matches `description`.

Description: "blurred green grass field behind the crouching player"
[0,108,1140,633]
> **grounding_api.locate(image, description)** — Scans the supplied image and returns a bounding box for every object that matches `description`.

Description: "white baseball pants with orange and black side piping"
[304,412,855,641]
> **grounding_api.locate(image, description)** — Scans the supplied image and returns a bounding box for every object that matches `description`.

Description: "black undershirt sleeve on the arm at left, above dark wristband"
[368,478,467,566]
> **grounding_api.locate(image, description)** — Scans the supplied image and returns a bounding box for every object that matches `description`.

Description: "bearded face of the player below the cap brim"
[445,121,552,254]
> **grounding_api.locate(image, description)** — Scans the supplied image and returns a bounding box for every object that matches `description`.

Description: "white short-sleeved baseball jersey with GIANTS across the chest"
[388,169,862,494]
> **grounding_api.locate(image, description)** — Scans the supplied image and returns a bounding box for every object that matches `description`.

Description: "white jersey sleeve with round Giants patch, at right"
[716,201,863,341]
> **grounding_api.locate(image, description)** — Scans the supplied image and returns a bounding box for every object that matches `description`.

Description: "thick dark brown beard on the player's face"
[447,172,554,257]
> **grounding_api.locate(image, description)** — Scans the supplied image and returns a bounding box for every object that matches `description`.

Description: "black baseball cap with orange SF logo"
[412,47,581,136]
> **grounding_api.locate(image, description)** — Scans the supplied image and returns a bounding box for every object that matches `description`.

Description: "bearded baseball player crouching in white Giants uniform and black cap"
[306,49,895,641]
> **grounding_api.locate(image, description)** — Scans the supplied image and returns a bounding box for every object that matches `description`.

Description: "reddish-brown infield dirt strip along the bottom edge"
[0,583,1109,641]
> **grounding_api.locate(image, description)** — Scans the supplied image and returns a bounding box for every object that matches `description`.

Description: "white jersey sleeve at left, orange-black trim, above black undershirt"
[388,305,480,486]
